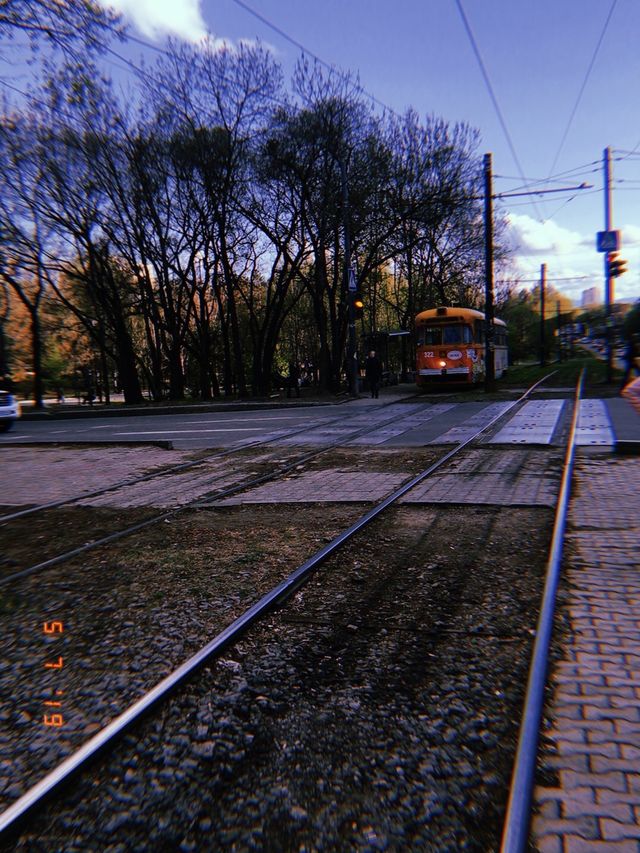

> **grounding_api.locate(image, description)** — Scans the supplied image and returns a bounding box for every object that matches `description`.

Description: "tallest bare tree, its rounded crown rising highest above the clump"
[148,38,281,394]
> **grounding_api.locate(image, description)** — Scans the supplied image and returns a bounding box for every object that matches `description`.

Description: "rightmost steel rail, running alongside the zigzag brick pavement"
[500,370,584,853]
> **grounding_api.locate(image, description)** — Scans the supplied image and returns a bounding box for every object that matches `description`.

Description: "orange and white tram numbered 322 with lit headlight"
[415,307,508,388]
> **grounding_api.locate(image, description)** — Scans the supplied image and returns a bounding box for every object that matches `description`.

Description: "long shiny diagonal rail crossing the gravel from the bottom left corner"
[0,374,552,836]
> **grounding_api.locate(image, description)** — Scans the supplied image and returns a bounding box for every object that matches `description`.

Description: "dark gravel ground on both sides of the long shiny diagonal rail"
[0,448,551,853]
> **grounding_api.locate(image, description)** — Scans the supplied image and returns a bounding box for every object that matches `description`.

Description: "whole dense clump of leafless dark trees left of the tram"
[0,35,510,401]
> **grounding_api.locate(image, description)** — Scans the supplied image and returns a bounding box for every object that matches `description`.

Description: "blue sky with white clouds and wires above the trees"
[75,0,640,305]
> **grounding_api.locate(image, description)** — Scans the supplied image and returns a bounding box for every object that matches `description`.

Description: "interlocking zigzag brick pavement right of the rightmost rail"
[533,456,640,853]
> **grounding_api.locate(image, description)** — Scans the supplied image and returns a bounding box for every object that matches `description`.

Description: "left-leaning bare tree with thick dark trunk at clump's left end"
[6,65,142,402]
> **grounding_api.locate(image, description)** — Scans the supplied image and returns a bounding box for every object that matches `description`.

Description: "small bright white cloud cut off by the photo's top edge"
[103,0,207,41]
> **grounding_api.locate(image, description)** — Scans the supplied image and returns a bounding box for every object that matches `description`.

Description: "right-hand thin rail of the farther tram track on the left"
[0,403,430,587]
